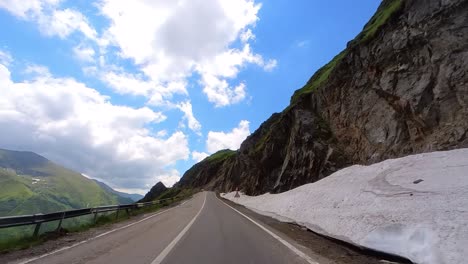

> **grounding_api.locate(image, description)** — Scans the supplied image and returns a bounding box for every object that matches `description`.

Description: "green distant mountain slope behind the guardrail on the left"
[0,149,120,217]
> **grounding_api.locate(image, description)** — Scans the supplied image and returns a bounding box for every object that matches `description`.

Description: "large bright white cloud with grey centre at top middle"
[99,0,276,107]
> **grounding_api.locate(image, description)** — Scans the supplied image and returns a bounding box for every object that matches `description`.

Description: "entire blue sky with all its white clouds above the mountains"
[0,0,380,193]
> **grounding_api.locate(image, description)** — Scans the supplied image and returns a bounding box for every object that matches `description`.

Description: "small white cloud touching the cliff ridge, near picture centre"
[206,120,250,153]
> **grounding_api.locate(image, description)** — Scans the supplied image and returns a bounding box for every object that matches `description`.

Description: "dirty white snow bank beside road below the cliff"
[223,149,468,264]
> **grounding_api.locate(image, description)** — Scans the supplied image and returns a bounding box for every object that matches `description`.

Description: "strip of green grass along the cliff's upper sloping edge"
[291,0,403,105]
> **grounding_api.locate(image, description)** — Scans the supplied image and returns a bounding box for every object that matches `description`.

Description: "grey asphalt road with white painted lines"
[15,192,315,264]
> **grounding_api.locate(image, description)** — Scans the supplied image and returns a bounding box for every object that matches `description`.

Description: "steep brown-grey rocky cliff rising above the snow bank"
[178,0,468,195]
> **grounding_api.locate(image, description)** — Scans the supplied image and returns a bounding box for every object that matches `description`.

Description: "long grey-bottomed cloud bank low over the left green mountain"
[0,59,190,190]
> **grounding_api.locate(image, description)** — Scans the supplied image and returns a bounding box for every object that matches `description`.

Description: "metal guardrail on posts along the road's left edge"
[0,198,174,237]
